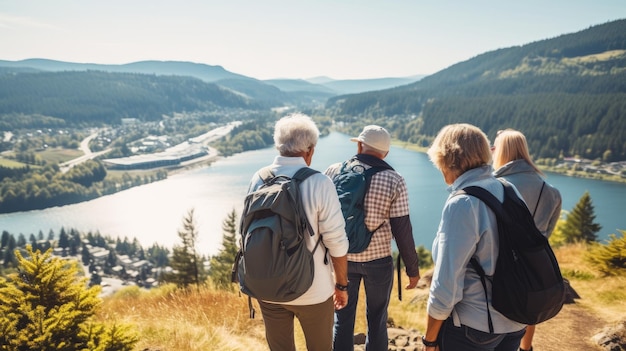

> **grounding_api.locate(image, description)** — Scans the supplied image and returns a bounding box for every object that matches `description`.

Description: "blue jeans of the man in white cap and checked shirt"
[333,256,393,351]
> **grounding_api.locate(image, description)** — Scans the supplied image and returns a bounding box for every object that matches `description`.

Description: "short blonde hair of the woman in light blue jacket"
[427,123,491,177]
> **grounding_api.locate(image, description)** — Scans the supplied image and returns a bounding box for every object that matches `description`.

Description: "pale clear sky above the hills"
[0,0,626,79]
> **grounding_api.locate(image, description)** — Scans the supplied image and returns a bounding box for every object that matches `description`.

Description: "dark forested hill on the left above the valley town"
[0,71,267,125]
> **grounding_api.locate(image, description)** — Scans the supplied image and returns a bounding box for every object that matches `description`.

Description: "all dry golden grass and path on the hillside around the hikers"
[98,245,626,351]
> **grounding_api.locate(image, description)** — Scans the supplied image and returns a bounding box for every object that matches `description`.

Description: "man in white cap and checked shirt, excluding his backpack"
[325,125,420,351]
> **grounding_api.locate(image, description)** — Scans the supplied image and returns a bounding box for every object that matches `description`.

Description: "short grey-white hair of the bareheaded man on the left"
[274,113,320,156]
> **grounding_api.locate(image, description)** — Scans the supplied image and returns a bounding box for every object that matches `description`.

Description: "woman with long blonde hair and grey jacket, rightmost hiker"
[492,129,561,351]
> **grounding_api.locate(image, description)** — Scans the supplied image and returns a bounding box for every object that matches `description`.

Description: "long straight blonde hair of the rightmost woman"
[493,128,543,175]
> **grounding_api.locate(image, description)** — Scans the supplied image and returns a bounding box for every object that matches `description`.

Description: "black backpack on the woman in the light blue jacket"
[461,181,565,333]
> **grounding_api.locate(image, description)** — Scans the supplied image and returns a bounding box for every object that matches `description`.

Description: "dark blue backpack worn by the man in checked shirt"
[333,155,393,253]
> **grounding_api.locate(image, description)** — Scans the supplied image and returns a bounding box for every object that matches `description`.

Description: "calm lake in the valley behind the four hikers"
[0,132,626,255]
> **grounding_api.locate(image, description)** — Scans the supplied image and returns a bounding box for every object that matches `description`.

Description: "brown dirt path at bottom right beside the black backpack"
[533,304,606,351]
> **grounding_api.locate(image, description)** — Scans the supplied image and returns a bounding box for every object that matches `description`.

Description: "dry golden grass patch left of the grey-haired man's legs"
[98,286,265,351]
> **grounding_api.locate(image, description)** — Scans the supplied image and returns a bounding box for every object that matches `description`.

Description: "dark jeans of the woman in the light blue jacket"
[439,318,526,351]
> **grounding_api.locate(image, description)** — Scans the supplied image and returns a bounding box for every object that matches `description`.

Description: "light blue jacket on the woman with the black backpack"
[427,166,525,334]
